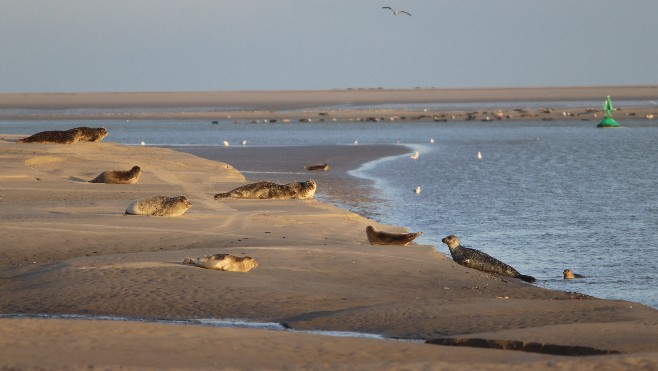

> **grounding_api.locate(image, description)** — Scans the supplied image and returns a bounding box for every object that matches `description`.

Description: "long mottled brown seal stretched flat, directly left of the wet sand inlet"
[215,179,317,200]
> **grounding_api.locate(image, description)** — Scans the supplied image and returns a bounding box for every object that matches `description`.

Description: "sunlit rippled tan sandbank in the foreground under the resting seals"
[0,133,658,369]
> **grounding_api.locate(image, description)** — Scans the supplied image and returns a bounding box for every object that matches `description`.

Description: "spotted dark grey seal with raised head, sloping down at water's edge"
[441,234,535,282]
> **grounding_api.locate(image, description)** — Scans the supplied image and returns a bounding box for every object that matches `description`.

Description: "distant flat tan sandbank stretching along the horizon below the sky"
[0,85,658,122]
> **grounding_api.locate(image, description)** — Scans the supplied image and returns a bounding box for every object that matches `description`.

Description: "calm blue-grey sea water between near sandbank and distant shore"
[0,120,658,308]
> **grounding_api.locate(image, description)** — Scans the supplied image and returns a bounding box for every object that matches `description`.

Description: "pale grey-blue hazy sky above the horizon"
[0,0,658,93]
